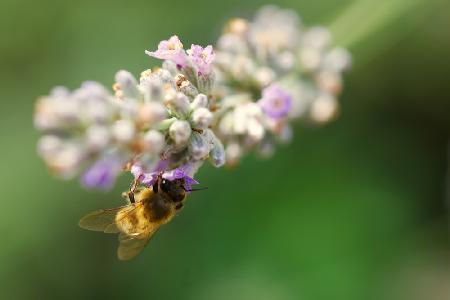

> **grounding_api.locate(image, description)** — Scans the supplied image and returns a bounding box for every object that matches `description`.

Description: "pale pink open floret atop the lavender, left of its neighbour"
[145,35,187,68]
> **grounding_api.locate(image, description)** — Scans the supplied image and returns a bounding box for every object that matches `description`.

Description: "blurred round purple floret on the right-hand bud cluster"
[258,84,292,120]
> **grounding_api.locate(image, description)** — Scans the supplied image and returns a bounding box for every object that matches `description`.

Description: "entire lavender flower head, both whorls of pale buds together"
[35,6,350,190]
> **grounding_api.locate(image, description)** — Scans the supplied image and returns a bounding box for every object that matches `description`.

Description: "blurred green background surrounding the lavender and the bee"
[0,0,450,300]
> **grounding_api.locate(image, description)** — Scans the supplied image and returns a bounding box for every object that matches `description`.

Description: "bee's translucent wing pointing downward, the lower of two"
[117,226,159,260]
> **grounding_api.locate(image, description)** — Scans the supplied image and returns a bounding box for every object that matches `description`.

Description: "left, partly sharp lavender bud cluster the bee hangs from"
[35,36,225,189]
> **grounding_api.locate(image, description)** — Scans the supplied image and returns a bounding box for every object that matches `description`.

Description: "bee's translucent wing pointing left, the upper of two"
[78,206,134,233]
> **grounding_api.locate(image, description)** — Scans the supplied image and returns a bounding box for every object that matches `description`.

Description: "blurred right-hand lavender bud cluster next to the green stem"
[213,6,350,163]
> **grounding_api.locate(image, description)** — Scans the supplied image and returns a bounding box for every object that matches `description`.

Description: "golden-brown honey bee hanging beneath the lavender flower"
[79,176,187,260]
